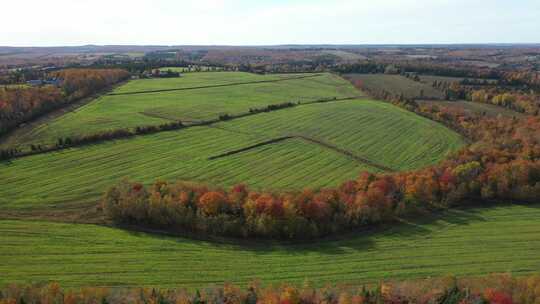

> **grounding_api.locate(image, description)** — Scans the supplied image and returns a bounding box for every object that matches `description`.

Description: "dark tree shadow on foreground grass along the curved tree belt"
[117,203,540,256]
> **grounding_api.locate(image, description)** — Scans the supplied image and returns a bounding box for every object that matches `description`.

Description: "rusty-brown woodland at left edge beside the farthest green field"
[0,69,129,135]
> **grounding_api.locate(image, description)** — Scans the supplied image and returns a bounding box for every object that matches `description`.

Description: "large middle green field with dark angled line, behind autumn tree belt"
[0,100,462,210]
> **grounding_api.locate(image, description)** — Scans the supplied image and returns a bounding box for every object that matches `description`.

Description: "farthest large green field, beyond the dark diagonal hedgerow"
[4,72,359,146]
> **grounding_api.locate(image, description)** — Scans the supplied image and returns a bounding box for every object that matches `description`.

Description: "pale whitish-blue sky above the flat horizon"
[0,0,540,46]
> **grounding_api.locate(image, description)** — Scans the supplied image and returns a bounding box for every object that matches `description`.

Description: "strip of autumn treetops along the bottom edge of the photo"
[0,275,540,304]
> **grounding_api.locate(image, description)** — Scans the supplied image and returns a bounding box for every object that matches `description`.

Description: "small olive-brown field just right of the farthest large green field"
[345,74,444,99]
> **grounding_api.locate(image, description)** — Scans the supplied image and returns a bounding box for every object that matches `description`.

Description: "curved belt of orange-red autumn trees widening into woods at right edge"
[103,72,540,238]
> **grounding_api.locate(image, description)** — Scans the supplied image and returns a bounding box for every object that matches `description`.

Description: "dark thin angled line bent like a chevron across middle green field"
[208,135,396,172]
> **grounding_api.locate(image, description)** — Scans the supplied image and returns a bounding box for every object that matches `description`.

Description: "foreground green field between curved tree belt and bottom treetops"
[0,205,540,288]
